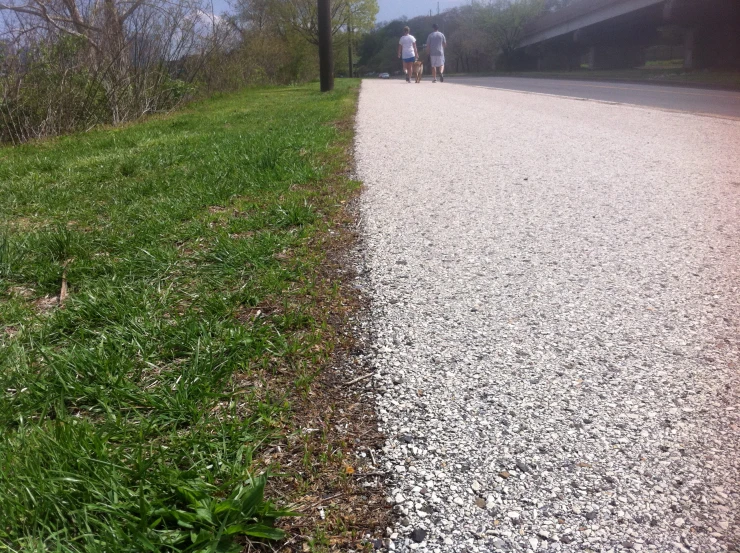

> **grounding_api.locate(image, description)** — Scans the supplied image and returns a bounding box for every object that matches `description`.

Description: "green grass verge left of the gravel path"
[0,80,358,552]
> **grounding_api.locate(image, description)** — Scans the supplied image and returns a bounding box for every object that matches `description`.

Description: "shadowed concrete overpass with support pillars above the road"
[520,0,740,69]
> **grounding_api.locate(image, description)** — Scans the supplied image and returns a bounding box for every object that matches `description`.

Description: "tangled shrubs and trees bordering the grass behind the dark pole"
[0,0,378,144]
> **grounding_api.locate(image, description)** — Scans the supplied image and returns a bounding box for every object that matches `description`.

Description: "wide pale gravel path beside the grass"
[356,81,740,552]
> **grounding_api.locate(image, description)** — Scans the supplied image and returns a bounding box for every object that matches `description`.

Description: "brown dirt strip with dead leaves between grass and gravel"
[247,196,391,553]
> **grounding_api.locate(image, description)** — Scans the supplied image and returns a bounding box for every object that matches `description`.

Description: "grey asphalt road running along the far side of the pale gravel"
[445,76,740,118]
